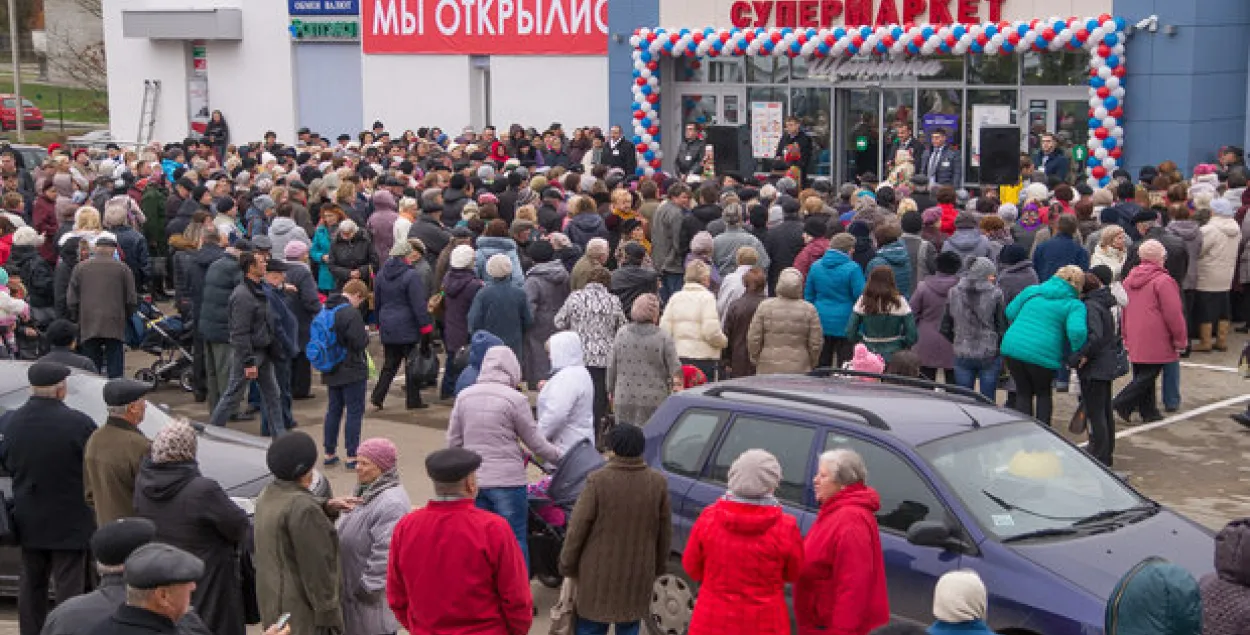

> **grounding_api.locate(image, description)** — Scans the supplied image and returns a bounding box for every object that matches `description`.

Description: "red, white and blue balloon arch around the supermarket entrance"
[630,14,1126,186]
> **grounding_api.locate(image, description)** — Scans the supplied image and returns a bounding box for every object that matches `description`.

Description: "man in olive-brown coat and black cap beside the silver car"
[83,379,153,526]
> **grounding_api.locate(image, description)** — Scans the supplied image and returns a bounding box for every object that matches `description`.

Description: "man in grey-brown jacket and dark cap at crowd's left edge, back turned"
[65,234,139,379]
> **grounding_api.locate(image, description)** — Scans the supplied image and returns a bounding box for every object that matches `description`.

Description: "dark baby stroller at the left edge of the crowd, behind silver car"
[126,296,195,393]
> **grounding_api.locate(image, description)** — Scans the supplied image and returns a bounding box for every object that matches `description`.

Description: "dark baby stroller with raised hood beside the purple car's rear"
[528,439,605,589]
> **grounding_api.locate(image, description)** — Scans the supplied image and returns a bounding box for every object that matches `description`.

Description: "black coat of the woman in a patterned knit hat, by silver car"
[135,459,251,635]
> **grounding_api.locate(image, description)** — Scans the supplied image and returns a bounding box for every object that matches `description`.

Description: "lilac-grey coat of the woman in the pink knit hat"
[338,485,413,635]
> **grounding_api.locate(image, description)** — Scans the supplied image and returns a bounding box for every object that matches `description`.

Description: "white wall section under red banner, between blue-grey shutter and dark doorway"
[367,55,470,135]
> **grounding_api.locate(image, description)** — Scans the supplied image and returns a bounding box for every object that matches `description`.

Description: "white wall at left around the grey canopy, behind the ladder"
[104,0,295,143]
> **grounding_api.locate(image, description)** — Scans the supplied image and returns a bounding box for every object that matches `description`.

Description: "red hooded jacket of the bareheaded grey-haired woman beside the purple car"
[795,484,890,635]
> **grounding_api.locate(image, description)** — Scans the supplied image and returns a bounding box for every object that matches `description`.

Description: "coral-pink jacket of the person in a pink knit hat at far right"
[1120,260,1195,364]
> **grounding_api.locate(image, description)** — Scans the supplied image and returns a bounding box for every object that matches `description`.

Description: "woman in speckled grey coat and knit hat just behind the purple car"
[608,294,683,426]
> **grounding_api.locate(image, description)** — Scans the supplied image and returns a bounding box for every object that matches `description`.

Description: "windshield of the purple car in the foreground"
[918,421,1154,541]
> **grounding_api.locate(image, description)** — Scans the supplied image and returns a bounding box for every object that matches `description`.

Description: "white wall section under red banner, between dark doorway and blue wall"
[490,55,608,130]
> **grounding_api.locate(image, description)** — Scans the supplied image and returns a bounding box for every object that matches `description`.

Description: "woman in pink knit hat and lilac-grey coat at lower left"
[336,439,413,635]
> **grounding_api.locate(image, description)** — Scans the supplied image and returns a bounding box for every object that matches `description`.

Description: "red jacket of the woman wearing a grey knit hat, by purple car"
[681,499,803,635]
